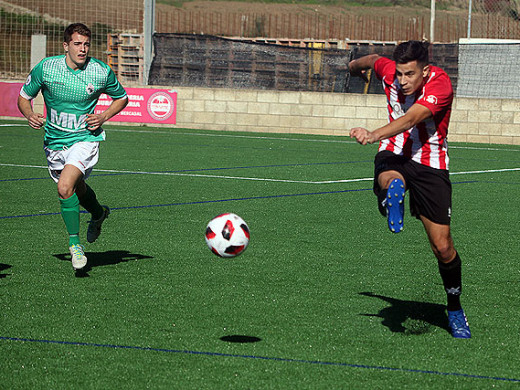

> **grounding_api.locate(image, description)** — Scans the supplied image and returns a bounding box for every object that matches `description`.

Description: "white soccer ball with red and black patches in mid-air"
[205,213,249,257]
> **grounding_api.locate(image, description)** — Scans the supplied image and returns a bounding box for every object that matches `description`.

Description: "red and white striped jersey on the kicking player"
[374,57,453,170]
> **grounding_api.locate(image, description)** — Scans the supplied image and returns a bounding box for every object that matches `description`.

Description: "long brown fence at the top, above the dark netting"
[156,0,520,43]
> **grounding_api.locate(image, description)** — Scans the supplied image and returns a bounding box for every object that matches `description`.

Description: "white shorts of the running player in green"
[43,142,99,183]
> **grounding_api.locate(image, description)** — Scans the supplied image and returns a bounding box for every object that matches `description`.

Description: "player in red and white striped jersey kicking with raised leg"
[349,41,471,338]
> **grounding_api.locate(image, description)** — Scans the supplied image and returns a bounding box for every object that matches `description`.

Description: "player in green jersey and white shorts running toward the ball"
[18,23,128,270]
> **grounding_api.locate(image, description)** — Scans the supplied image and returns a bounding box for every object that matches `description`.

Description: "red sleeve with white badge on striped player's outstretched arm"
[416,71,453,116]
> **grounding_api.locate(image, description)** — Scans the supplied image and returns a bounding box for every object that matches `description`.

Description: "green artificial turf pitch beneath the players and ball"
[0,121,520,389]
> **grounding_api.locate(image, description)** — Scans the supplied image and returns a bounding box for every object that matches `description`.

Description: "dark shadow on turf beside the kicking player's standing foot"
[359,292,450,335]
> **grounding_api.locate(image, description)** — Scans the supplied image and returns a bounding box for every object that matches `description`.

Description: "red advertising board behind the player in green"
[0,82,177,124]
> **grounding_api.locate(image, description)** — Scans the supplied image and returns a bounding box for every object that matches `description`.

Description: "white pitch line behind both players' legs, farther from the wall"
[0,163,520,184]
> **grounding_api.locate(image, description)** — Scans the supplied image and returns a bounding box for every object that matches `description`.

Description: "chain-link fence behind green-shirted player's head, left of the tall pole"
[0,0,144,79]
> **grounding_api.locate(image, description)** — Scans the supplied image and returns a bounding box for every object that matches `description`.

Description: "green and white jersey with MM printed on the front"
[20,55,126,150]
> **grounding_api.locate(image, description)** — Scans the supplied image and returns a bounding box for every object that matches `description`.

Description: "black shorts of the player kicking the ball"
[374,150,451,225]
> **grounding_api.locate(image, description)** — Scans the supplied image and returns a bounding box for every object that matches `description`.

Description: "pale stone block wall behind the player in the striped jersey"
[25,87,520,145]
